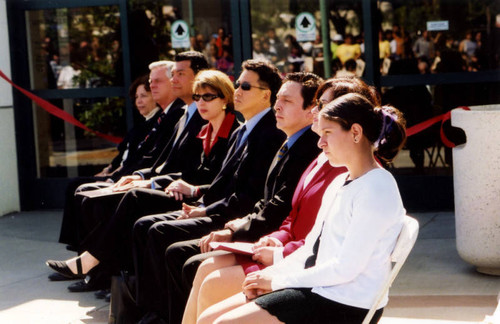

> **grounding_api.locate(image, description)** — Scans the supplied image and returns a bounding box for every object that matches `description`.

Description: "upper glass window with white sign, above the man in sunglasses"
[250,0,365,76]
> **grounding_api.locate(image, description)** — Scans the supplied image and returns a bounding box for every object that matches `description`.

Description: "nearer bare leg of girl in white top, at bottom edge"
[214,302,283,324]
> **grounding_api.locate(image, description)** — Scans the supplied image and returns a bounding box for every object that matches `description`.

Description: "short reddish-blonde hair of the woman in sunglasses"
[193,70,234,110]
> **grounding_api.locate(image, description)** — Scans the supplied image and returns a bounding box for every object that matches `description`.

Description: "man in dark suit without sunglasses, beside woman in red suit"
[165,72,322,323]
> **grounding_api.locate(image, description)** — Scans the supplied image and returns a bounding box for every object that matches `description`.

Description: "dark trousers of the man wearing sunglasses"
[133,210,225,323]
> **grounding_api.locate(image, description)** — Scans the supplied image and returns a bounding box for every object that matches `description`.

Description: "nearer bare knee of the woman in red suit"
[198,265,245,316]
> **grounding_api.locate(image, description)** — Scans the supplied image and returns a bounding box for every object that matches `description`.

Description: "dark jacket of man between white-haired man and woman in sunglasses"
[138,110,206,179]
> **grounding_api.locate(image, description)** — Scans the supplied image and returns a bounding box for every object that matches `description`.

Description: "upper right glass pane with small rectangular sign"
[378,0,500,75]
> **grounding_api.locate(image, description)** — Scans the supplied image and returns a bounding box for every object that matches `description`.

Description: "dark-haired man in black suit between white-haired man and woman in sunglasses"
[47,52,208,291]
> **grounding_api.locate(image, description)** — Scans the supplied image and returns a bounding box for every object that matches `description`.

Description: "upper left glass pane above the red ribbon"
[26,6,123,89]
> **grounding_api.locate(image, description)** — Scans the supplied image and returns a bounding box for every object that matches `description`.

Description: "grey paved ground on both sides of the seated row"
[0,211,500,324]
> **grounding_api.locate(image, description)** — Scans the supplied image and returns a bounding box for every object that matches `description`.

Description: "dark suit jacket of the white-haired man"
[111,99,185,181]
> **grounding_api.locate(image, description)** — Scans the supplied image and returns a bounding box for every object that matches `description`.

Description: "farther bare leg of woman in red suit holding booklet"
[182,254,236,324]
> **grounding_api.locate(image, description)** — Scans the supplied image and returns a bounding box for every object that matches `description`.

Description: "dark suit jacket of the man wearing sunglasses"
[199,110,285,223]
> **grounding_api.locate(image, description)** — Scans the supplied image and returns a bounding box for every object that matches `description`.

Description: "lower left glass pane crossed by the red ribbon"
[33,97,126,178]
